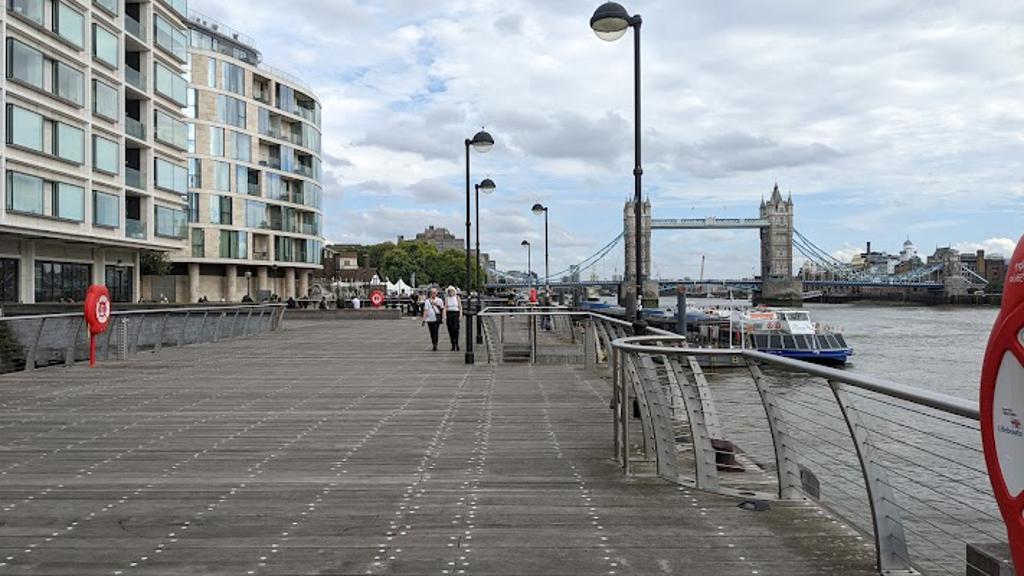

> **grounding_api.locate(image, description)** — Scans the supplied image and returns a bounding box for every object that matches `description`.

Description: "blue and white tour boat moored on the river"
[737,307,853,365]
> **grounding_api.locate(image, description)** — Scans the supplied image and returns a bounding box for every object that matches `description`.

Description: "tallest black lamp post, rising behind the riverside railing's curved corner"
[590,2,647,334]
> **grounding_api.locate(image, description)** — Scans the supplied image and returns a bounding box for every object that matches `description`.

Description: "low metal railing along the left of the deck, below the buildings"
[0,304,285,373]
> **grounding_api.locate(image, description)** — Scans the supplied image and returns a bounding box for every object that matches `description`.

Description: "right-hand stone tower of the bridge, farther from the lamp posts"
[760,183,804,305]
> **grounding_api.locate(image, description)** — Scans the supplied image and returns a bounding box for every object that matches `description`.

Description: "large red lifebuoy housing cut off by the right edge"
[981,231,1024,570]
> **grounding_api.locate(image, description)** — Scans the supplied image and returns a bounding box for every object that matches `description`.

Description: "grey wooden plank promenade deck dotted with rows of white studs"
[0,318,873,576]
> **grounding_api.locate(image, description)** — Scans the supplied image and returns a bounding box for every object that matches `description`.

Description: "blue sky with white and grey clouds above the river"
[190,0,1024,278]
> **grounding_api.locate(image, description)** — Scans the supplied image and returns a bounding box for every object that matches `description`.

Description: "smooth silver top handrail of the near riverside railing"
[611,336,981,421]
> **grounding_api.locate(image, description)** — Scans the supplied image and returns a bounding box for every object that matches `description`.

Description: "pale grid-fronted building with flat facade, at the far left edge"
[0,0,187,303]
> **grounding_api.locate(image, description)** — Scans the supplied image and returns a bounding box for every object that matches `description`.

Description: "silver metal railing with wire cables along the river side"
[480,308,1007,575]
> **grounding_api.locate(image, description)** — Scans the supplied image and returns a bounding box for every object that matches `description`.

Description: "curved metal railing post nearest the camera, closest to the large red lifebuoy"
[828,380,918,576]
